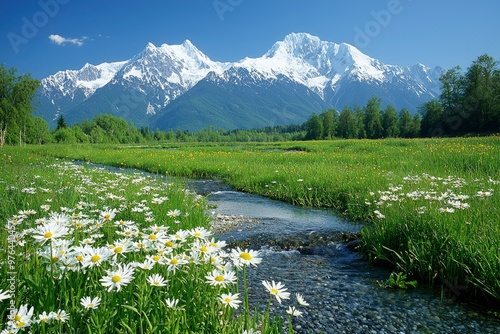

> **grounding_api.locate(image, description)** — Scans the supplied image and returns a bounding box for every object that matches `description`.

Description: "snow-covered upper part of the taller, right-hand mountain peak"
[228,33,441,98]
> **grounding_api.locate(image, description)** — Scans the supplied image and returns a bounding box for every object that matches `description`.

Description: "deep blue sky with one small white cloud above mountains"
[0,0,500,79]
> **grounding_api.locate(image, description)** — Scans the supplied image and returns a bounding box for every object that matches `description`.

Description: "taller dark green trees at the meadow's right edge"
[305,55,500,139]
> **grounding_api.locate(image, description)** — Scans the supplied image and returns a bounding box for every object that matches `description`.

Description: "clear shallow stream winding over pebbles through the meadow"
[188,180,500,333]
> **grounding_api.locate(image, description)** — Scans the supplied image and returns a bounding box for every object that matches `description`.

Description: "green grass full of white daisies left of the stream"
[0,147,304,333]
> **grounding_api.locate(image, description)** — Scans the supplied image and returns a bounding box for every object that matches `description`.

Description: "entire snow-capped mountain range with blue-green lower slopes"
[35,33,443,131]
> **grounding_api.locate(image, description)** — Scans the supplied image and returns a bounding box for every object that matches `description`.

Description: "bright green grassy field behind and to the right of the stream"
[0,136,500,332]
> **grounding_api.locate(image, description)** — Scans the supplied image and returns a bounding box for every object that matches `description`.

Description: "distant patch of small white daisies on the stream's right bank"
[365,174,500,220]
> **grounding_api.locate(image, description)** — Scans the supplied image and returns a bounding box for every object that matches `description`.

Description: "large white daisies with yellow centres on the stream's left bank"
[0,163,306,333]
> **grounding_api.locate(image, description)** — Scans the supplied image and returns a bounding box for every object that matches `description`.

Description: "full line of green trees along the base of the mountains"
[0,55,500,146]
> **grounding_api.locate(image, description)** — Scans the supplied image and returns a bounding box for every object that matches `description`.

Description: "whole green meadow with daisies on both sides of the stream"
[0,136,500,333]
